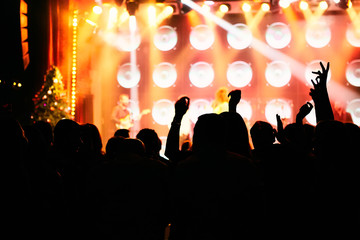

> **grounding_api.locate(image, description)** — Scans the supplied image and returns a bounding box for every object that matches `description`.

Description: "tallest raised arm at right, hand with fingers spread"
[310,62,334,122]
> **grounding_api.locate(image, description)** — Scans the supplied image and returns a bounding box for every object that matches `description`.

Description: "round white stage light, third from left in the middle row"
[189,62,215,88]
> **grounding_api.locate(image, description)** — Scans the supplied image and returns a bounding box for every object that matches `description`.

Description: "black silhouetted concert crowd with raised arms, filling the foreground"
[0,63,360,240]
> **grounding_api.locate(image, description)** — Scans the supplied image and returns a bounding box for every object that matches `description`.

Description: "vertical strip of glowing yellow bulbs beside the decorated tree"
[70,10,79,119]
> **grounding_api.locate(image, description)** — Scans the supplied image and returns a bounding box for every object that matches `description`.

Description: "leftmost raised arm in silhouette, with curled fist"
[165,97,190,162]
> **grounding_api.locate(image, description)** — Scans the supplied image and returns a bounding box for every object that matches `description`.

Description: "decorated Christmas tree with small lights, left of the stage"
[31,66,71,127]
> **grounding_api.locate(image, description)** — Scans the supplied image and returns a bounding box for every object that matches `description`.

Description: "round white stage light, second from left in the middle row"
[153,62,177,88]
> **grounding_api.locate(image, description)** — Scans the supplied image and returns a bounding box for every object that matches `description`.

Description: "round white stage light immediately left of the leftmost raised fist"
[151,99,175,125]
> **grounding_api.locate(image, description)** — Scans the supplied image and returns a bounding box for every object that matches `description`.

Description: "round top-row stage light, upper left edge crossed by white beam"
[227,23,253,50]
